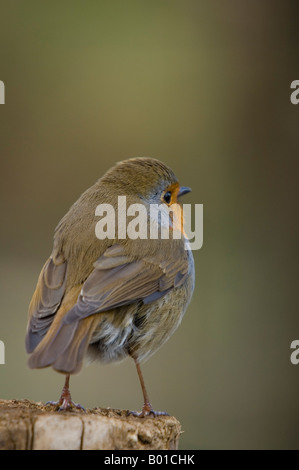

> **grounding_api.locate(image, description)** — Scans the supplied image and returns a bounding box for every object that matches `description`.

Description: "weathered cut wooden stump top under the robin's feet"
[0,400,181,450]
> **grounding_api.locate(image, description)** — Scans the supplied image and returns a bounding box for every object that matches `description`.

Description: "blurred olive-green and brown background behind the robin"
[0,0,299,449]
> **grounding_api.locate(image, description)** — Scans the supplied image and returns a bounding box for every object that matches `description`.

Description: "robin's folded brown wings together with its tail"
[27,245,188,373]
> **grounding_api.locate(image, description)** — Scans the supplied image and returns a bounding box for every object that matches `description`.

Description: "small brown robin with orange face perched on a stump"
[26,157,195,417]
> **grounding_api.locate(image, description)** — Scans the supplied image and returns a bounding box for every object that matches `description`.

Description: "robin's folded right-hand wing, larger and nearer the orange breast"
[63,247,188,323]
